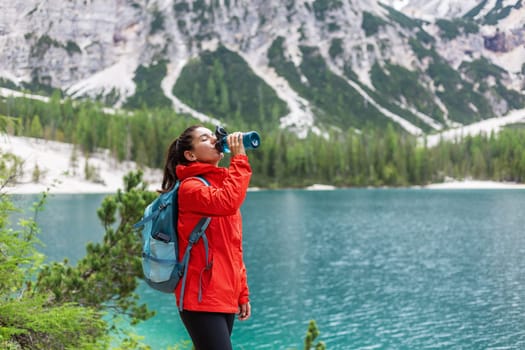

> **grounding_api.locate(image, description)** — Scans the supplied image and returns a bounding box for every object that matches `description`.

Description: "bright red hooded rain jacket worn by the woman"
[175,155,252,313]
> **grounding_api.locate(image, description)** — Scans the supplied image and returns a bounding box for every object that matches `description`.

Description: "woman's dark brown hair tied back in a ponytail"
[161,125,202,192]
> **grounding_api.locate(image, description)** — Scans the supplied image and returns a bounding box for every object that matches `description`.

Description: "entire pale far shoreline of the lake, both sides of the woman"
[0,135,525,194]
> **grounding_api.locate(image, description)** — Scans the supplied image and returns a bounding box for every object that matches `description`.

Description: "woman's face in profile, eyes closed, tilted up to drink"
[185,127,224,165]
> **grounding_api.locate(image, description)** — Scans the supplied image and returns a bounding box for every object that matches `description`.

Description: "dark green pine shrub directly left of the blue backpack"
[35,172,155,324]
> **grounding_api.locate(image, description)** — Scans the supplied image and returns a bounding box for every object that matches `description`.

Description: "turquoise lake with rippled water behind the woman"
[11,189,525,349]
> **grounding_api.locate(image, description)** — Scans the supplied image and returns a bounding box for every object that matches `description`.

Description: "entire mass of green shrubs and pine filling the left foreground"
[0,142,155,350]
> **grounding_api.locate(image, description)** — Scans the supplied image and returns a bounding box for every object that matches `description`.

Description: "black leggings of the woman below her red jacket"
[180,310,235,350]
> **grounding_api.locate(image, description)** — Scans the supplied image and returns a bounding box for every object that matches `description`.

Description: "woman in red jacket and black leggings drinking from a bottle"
[162,125,252,350]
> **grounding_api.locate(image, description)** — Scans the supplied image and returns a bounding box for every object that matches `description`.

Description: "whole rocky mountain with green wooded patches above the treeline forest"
[0,0,525,135]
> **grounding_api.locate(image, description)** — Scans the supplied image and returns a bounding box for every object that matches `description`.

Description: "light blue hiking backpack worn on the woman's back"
[133,176,211,311]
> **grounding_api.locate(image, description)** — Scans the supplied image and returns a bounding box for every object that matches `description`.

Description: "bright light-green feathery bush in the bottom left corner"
[0,190,109,350]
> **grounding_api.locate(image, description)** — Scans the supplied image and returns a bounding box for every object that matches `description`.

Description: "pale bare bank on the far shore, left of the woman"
[0,135,162,194]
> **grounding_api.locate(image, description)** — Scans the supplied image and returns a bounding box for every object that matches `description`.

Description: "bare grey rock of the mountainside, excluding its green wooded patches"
[0,0,525,133]
